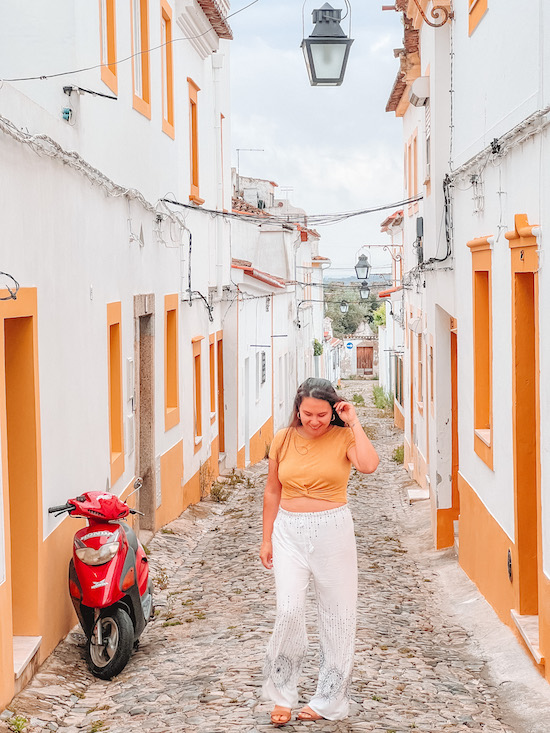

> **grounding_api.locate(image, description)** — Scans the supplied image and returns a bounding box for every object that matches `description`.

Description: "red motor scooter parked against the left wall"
[48,479,153,680]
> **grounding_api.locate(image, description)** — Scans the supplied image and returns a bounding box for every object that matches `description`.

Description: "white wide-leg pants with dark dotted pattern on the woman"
[263,505,357,720]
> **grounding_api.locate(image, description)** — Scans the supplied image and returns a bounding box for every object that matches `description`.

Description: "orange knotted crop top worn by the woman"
[269,425,355,502]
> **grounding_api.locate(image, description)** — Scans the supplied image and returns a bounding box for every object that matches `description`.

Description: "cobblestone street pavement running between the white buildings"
[0,380,550,733]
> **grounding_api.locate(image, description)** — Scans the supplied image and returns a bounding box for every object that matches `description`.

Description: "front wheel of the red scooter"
[86,608,134,680]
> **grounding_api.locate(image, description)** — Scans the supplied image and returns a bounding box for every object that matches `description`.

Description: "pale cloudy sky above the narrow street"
[229,0,403,277]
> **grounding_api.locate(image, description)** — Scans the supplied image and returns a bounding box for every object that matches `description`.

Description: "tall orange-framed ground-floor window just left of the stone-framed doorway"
[107,303,124,486]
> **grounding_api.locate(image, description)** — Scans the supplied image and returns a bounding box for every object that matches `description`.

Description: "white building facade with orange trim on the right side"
[389,0,550,678]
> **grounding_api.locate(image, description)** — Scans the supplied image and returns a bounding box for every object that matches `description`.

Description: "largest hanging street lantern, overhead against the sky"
[301,0,353,87]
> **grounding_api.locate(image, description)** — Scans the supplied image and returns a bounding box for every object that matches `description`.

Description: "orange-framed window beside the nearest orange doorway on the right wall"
[468,237,493,468]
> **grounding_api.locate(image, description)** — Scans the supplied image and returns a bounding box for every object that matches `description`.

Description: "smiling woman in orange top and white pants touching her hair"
[260,378,378,727]
